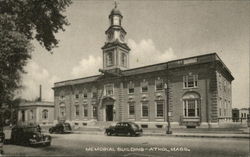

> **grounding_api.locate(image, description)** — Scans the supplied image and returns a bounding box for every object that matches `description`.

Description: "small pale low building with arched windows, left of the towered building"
[18,101,54,125]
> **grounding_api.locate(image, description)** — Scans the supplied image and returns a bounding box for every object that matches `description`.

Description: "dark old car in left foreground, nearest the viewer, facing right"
[10,126,51,146]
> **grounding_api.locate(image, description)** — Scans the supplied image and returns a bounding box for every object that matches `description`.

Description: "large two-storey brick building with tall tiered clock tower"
[53,4,234,128]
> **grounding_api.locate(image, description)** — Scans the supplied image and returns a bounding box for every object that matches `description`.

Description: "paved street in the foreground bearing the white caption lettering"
[4,134,249,157]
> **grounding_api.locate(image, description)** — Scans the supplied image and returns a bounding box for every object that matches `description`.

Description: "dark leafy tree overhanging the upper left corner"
[0,0,71,105]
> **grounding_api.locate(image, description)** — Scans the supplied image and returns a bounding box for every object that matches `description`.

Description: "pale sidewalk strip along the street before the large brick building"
[71,128,250,139]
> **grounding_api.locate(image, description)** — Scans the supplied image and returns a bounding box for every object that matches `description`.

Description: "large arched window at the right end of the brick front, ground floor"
[182,92,200,117]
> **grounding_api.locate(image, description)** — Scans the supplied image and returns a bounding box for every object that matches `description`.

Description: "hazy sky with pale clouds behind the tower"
[18,0,250,108]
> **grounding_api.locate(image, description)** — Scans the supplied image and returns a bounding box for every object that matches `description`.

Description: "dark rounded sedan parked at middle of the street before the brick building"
[105,122,143,136]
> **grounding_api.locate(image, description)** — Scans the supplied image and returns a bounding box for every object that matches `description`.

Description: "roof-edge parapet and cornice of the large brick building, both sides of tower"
[54,53,234,88]
